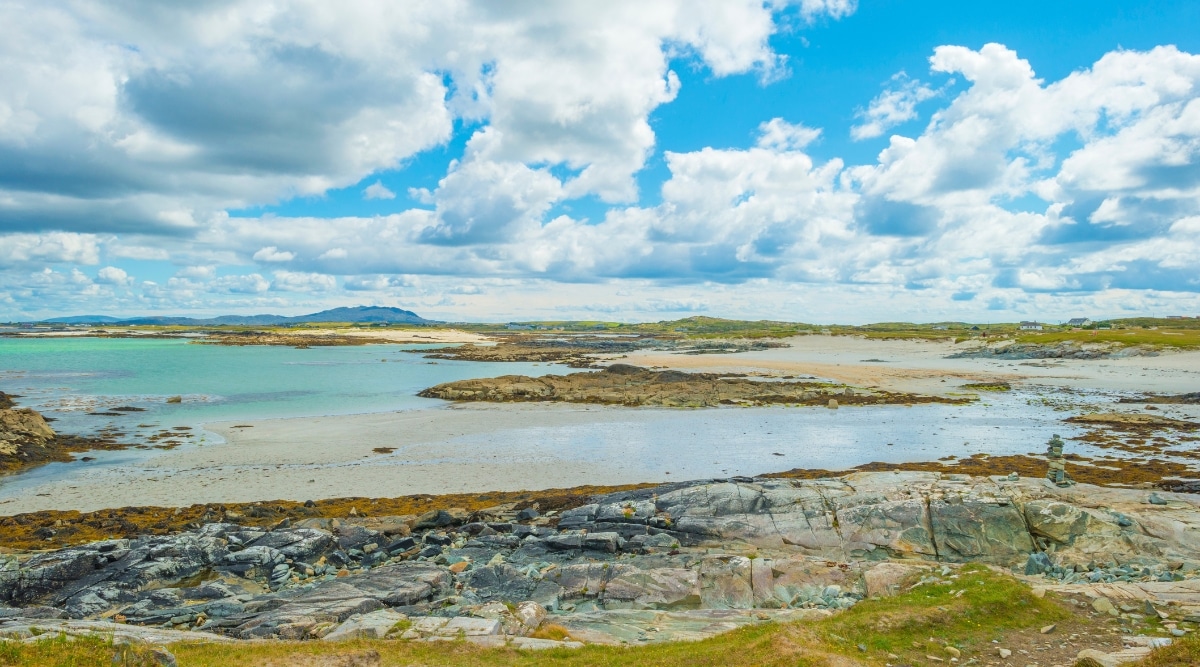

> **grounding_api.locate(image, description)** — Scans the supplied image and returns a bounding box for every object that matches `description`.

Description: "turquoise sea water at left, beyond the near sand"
[0,337,568,440]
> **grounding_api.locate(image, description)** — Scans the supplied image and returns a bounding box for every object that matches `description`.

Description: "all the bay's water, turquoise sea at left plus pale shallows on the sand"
[0,337,1112,497]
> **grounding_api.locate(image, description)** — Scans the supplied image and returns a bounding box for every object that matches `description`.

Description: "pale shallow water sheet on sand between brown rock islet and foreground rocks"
[396,392,1102,480]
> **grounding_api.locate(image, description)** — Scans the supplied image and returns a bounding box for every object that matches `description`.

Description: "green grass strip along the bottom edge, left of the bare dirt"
[0,565,1070,667]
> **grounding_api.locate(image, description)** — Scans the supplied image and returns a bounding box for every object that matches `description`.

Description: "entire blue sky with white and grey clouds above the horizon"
[0,0,1200,324]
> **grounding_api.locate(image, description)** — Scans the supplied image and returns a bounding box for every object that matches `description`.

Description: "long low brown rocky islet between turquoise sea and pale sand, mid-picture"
[419,363,970,408]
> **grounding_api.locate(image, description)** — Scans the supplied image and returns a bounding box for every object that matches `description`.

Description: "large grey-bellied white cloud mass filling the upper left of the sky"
[0,0,853,236]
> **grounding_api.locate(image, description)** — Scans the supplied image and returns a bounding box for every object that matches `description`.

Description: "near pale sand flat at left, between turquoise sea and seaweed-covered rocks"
[0,405,696,515]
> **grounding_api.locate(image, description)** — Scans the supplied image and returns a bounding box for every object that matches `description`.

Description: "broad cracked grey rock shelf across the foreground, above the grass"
[0,473,1200,648]
